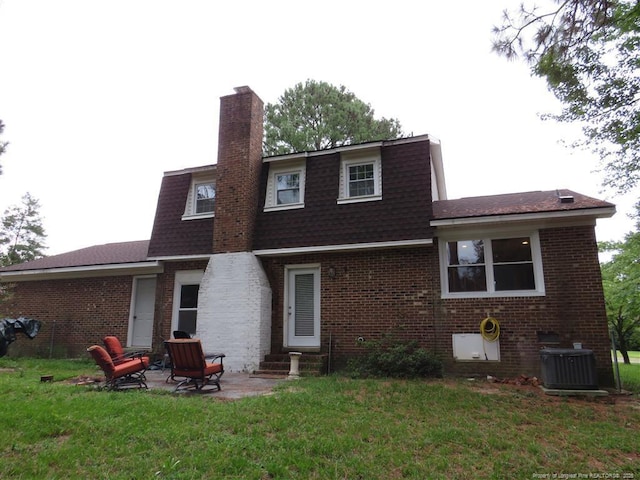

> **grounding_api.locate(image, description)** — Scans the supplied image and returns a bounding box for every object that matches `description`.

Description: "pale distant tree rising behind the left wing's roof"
[0,193,46,266]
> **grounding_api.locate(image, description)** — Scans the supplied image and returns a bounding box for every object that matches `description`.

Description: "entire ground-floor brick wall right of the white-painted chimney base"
[263,227,613,386]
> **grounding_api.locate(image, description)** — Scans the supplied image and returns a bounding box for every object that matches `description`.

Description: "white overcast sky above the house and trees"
[0,0,633,255]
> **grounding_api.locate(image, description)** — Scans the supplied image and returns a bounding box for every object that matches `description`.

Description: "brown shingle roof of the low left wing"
[0,240,149,273]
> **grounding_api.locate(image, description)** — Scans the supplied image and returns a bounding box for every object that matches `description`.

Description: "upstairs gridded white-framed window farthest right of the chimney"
[338,149,382,203]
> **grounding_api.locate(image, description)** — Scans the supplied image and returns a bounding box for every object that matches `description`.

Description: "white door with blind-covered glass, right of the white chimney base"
[285,267,320,348]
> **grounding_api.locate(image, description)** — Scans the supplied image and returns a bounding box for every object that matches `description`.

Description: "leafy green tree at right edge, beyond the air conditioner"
[599,223,640,363]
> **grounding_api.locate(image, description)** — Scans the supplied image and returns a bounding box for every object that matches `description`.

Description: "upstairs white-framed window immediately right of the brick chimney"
[264,162,306,211]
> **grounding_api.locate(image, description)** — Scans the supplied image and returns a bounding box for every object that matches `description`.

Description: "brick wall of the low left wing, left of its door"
[0,276,133,357]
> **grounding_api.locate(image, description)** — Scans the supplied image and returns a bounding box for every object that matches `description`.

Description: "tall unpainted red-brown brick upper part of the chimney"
[213,87,264,253]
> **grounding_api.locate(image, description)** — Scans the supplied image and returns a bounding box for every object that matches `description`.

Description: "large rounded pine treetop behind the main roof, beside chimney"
[263,80,403,155]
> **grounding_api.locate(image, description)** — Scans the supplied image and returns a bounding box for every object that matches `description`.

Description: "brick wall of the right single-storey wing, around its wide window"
[436,226,613,386]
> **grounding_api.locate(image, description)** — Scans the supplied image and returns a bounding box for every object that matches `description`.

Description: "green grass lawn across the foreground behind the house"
[0,359,640,479]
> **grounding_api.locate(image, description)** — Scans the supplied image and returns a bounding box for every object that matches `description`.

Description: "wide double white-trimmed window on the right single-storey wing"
[440,232,544,297]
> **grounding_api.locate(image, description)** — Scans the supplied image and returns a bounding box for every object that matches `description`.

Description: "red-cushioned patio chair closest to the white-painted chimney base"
[164,338,225,392]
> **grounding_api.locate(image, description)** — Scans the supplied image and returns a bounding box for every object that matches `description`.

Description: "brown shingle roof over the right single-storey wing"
[433,190,615,220]
